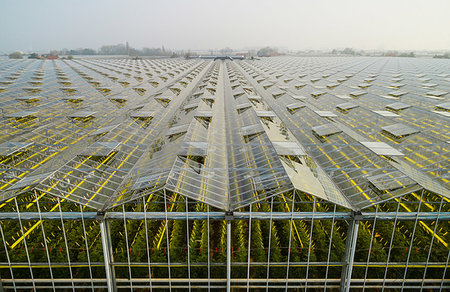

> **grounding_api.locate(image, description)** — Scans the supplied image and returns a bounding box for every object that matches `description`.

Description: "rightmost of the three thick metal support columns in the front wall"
[340,214,361,292]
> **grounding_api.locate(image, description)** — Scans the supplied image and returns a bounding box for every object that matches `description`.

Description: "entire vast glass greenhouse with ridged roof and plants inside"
[0,57,450,291]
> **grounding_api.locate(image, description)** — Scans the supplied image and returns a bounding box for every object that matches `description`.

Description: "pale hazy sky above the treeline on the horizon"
[0,0,450,53]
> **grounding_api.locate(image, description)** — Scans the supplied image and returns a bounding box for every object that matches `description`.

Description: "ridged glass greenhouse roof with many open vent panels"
[0,57,450,211]
